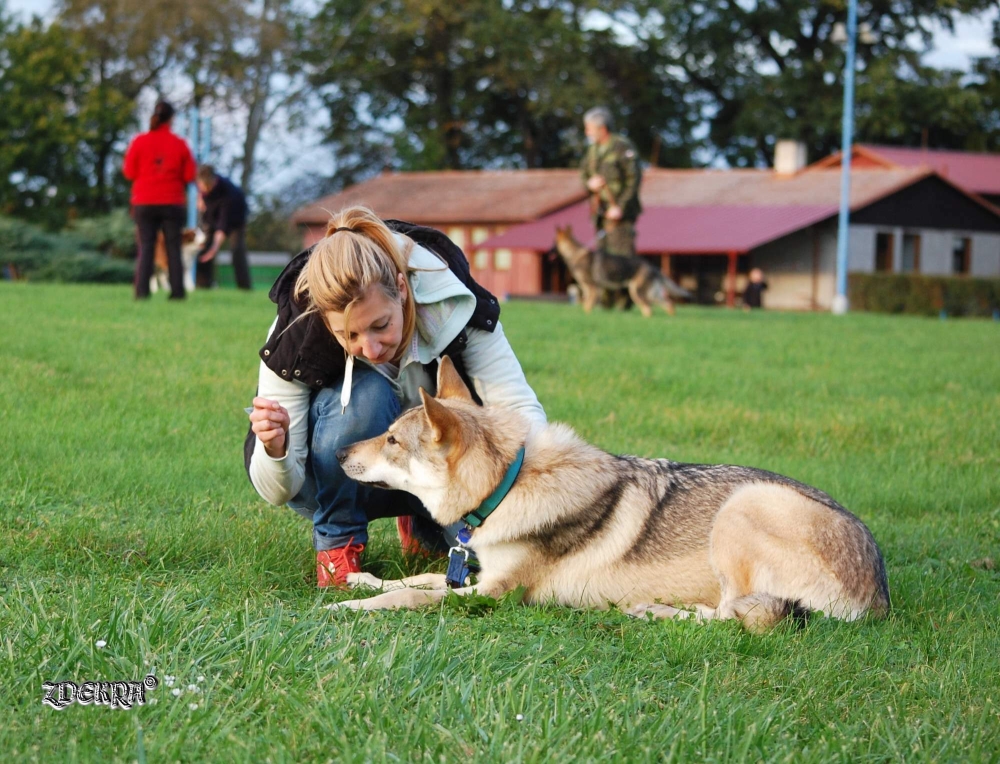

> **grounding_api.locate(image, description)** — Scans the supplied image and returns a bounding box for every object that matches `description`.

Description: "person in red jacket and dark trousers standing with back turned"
[122,101,197,300]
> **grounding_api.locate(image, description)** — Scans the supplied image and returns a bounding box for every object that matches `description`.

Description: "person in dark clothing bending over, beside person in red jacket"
[196,164,251,289]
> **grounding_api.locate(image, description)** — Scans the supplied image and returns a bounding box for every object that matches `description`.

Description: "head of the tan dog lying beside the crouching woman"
[337,356,516,525]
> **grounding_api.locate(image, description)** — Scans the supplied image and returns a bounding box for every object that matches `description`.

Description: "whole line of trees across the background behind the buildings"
[0,0,1000,226]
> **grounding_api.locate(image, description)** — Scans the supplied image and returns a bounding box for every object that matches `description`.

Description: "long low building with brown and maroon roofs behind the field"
[294,146,1000,310]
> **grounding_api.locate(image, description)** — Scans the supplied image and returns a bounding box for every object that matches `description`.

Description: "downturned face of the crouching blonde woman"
[326,274,408,363]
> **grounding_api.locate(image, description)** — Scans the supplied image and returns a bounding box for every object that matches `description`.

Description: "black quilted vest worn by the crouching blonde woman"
[243,220,500,472]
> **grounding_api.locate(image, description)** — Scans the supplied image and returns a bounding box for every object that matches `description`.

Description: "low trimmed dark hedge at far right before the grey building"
[848,273,1000,316]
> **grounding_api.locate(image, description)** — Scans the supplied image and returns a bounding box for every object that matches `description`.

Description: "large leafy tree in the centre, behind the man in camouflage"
[306,0,695,181]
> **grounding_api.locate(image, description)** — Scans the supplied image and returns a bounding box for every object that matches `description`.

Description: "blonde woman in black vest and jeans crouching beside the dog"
[245,207,545,587]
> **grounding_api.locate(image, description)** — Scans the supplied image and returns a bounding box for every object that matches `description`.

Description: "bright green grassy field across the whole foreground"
[0,283,1000,762]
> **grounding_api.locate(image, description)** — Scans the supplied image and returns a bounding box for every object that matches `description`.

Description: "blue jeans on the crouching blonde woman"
[288,363,442,552]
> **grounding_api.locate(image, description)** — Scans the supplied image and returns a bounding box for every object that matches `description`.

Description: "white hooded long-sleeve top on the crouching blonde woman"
[250,234,546,505]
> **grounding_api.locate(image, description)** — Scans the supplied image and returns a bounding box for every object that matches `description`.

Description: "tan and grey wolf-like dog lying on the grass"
[330,357,889,631]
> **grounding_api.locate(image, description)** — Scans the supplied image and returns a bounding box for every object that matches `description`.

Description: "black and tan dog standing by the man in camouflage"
[555,226,691,318]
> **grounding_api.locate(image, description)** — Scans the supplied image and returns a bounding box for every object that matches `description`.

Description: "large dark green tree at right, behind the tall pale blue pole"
[633,0,995,166]
